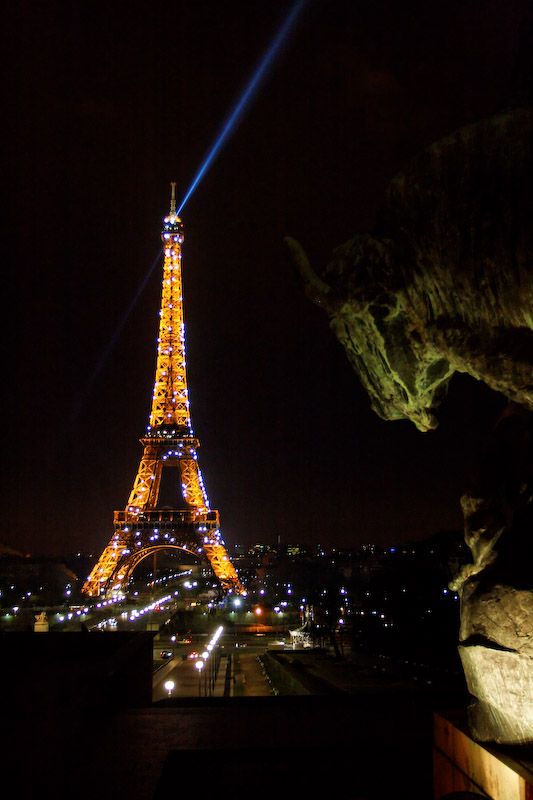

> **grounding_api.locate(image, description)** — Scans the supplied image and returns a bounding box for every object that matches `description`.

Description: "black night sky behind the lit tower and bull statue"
[0,0,529,555]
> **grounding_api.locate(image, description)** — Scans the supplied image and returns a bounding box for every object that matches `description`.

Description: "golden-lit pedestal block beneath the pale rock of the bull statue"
[433,712,533,800]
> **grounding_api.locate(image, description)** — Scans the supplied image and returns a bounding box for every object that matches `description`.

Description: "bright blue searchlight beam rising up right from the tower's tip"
[176,0,307,216]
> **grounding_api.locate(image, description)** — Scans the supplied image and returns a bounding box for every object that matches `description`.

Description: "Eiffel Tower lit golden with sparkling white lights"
[83,188,245,597]
